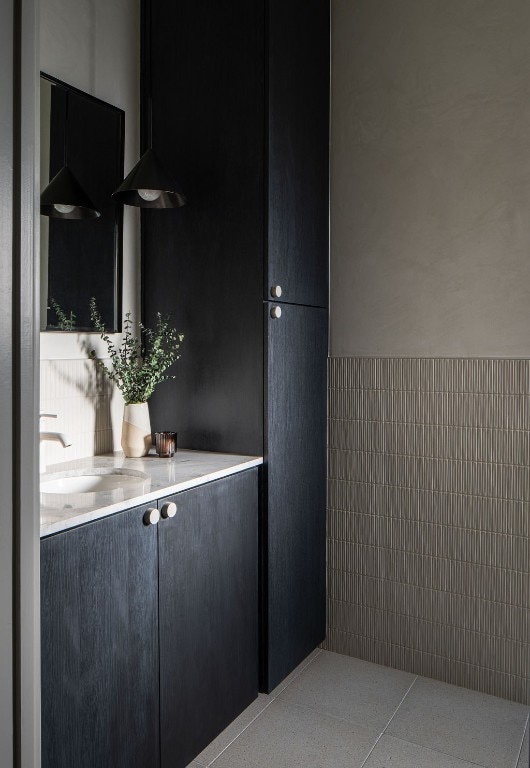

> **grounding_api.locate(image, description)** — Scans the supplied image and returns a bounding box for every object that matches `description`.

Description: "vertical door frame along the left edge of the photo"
[0,0,40,768]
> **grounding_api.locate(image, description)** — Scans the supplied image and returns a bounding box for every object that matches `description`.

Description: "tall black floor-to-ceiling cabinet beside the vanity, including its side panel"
[142,0,329,691]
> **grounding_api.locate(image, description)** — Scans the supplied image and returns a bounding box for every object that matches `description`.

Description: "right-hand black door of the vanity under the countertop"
[158,470,258,768]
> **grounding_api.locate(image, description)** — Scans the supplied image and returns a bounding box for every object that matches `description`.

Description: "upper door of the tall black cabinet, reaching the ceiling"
[265,0,329,307]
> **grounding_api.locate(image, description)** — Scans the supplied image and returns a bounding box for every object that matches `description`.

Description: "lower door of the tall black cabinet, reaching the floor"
[261,305,327,691]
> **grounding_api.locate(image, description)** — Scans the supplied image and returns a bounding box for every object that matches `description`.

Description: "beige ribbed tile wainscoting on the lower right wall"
[324,358,530,703]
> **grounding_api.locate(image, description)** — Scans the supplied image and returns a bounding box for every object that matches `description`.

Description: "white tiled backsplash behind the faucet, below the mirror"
[40,360,123,464]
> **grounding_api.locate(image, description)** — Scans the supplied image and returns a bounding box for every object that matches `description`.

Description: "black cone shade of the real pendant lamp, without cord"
[112,149,186,208]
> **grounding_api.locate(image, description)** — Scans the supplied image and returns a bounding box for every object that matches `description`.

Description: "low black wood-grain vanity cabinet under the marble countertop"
[41,469,258,768]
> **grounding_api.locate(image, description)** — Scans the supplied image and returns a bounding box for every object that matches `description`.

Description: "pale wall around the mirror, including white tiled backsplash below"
[40,0,140,464]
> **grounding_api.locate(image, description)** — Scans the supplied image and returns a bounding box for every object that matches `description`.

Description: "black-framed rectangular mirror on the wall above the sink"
[40,73,125,333]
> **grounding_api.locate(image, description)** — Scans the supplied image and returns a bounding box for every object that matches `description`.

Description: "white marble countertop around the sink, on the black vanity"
[40,450,263,538]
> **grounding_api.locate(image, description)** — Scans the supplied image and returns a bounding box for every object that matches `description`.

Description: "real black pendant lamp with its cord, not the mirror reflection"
[112,3,186,208]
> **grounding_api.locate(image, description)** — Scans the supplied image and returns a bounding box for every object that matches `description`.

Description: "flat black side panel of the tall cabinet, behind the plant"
[143,0,264,454]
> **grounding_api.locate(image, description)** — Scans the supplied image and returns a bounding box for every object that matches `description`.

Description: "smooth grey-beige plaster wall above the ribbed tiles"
[331,0,530,357]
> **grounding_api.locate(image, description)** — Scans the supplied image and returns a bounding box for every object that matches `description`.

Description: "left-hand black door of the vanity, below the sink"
[41,507,159,768]
